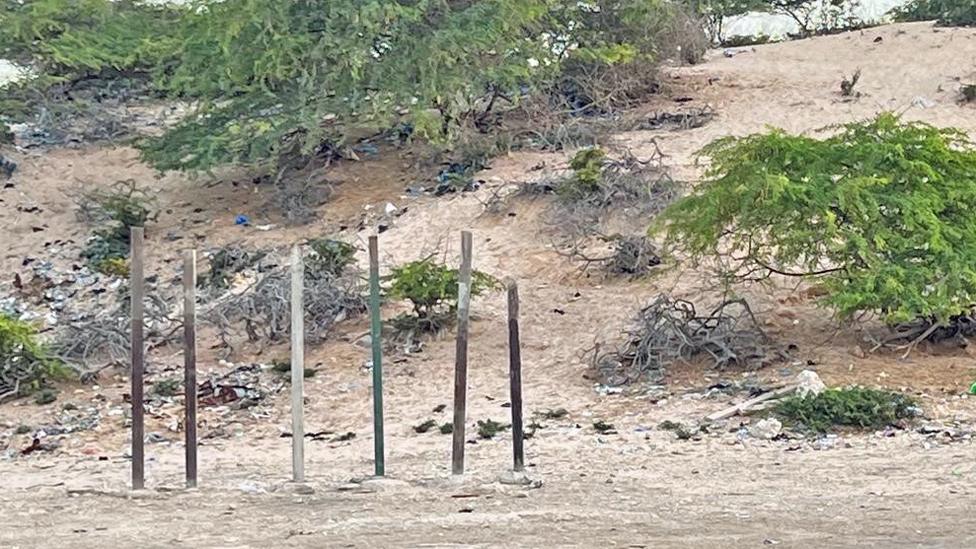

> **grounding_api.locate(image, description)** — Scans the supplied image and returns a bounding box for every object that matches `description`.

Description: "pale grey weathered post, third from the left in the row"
[291,245,305,482]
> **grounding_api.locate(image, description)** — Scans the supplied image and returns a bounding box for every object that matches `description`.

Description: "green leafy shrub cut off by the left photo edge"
[0,314,68,394]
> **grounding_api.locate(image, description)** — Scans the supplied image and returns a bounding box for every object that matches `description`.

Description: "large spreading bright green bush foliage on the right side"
[652,114,976,324]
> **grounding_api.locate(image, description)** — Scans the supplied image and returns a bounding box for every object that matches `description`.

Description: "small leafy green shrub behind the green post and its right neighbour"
[388,257,498,332]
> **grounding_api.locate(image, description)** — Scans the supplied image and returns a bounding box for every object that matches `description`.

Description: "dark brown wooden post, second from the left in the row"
[183,250,197,488]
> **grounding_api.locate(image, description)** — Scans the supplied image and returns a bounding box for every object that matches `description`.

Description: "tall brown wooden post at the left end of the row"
[129,227,146,490]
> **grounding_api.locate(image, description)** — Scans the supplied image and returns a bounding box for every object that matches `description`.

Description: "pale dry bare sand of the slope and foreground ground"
[0,24,976,548]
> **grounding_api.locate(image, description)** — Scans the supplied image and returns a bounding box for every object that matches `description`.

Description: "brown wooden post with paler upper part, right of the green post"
[451,231,471,475]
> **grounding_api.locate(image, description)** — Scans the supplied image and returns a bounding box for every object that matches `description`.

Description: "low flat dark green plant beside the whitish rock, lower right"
[772,387,917,433]
